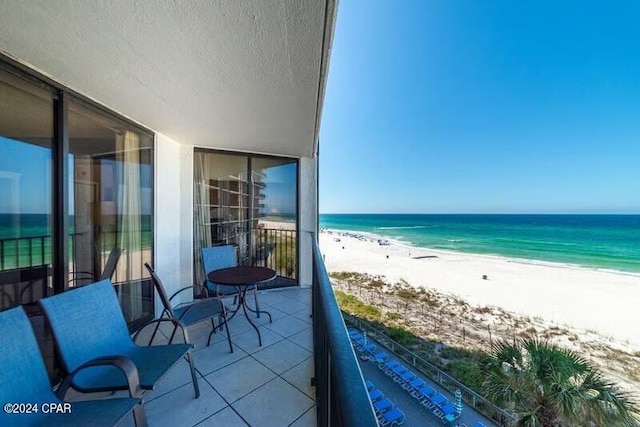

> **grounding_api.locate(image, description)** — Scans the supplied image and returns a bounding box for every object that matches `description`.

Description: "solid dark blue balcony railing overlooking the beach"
[312,235,378,427]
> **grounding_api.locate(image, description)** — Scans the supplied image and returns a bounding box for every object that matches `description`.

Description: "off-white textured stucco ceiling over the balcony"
[0,0,336,157]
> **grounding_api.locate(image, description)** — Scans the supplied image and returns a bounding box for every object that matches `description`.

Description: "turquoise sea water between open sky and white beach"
[320,214,640,273]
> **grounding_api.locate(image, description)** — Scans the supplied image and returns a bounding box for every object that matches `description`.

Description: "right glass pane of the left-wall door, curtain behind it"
[69,102,153,321]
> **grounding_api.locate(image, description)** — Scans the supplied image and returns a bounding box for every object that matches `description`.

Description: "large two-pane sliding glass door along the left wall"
[0,63,153,359]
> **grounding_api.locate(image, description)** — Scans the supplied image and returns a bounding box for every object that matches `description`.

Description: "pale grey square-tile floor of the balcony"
[100,287,316,427]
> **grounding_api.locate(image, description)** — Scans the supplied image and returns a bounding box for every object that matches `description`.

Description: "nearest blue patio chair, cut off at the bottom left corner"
[0,306,147,427]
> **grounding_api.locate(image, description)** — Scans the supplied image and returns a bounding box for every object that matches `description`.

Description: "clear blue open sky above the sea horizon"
[320,0,640,213]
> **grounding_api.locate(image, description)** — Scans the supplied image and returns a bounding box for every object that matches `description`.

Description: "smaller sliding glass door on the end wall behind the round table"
[194,150,298,285]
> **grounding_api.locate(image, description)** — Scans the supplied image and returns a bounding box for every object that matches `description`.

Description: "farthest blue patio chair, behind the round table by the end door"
[201,245,260,318]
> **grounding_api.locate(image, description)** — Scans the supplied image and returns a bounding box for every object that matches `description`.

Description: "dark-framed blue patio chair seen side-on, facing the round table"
[144,262,233,353]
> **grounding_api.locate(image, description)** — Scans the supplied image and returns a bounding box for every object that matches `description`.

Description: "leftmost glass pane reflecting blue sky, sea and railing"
[0,71,53,310]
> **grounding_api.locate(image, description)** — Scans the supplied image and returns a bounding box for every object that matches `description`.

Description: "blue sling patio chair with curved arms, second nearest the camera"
[39,280,200,398]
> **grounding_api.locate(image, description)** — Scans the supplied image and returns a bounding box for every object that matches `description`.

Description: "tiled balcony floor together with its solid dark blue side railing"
[60,237,377,427]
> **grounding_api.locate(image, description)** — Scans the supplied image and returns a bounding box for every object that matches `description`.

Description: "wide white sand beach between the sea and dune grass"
[320,230,640,350]
